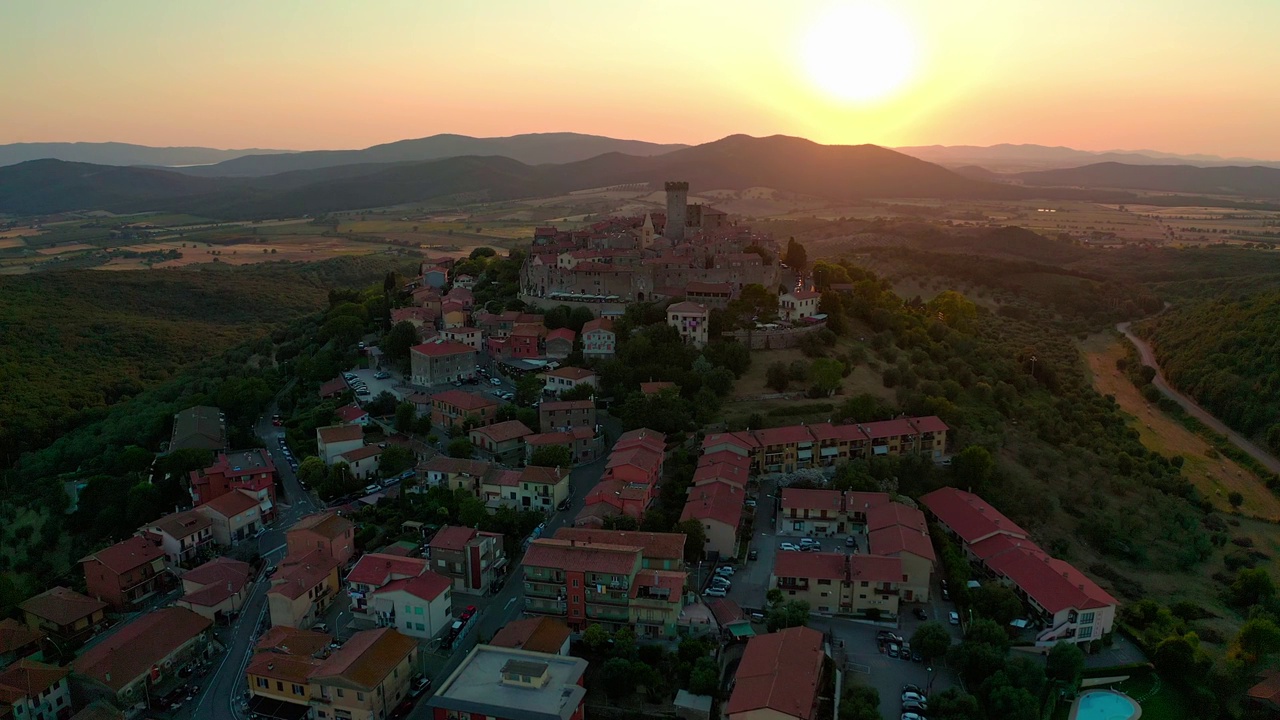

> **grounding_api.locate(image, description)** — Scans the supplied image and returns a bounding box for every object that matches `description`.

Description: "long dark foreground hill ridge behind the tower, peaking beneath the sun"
[0,135,1028,219]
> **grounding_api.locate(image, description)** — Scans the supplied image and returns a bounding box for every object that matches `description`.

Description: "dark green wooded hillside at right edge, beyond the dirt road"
[1140,291,1280,452]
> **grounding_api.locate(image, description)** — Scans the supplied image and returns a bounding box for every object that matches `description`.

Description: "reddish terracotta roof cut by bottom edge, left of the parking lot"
[724,628,826,720]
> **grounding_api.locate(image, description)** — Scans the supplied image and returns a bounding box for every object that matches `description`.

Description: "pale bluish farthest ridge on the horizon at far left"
[0,142,289,167]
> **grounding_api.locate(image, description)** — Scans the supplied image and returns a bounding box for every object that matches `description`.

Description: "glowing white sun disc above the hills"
[801,3,915,102]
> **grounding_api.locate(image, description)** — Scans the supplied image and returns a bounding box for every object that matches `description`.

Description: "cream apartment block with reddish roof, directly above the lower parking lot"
[769,551,902,620]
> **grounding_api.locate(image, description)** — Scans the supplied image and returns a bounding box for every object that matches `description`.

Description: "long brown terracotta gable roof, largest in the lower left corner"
[72,607,214,692]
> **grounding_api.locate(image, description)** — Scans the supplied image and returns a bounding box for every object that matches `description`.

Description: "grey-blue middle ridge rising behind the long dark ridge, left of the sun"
[179,132,687,177]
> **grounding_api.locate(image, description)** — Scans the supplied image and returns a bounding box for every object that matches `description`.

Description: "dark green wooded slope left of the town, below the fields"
[0,258,412,465]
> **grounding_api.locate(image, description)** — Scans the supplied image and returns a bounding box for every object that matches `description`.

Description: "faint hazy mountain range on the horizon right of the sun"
[895,143,1280,173]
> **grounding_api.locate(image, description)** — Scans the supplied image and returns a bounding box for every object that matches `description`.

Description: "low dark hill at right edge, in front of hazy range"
[1010,163,1280,200]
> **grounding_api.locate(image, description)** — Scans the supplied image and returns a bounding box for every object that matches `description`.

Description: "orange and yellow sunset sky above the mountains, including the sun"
[0,0,1280,159]
